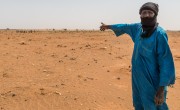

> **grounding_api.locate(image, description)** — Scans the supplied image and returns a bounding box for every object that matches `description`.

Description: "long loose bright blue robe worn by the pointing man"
[110,23,175,110]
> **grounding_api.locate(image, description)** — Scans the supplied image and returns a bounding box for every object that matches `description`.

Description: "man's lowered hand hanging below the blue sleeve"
[154,86,164,105]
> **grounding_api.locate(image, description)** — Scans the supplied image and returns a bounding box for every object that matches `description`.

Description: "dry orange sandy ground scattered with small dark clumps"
[0,30,180,110]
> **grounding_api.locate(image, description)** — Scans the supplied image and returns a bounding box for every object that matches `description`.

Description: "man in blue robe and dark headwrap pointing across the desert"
[100,2,175,110]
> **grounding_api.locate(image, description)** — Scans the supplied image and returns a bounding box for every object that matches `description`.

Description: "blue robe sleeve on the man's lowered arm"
[157,32,175,86]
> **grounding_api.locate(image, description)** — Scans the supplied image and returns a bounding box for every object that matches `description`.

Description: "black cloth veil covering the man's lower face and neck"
[141,15,158,38]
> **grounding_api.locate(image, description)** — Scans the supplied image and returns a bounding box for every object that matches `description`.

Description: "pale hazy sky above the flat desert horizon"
[0,0,180,30]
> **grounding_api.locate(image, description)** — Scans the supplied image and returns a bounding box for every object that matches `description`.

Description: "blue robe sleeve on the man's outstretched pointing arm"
[110,23,140,42]
